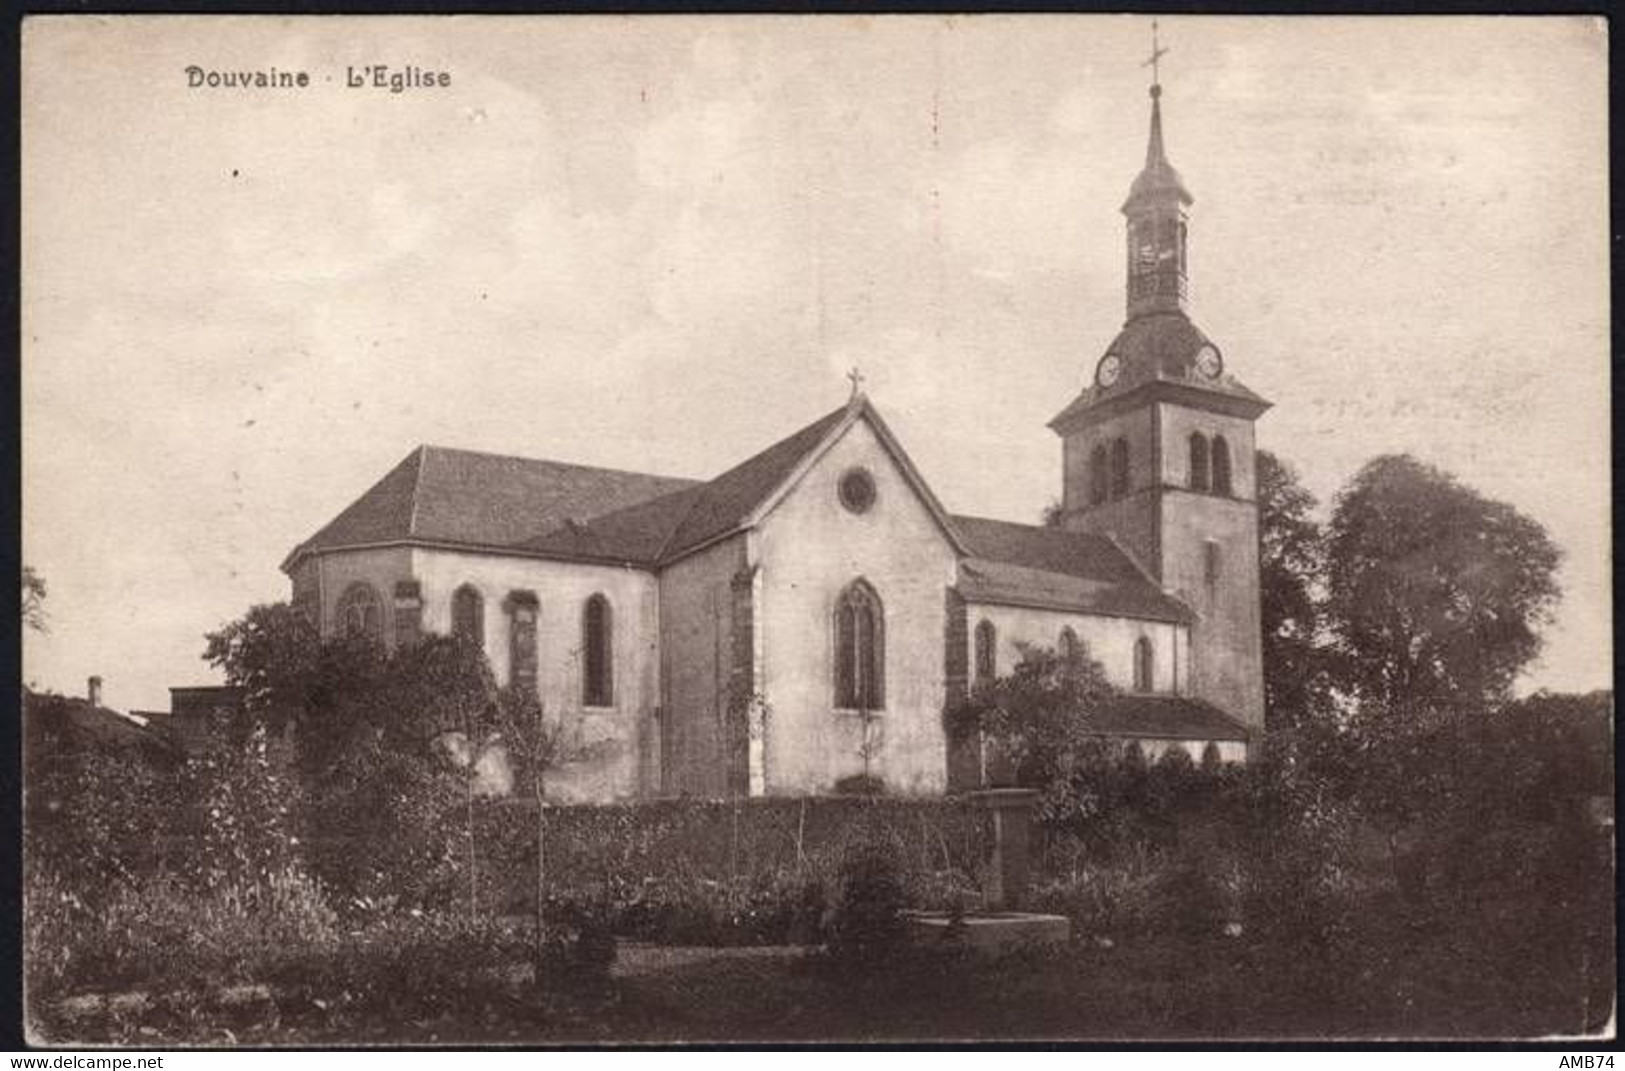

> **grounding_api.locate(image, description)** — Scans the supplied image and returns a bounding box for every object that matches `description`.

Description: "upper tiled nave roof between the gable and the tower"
[954,517,1193,622]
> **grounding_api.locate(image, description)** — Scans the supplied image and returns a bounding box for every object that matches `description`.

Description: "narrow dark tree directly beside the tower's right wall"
[1258,450,1328,726]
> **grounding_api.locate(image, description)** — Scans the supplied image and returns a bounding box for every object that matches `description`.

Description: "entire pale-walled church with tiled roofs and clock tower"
[283,85,1268,800]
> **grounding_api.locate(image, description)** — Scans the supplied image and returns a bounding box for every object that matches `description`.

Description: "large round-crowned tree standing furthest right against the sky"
[1326,455,1560,715]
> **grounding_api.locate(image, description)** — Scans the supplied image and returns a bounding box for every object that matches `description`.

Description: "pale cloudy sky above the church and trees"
[23,15,1612,710]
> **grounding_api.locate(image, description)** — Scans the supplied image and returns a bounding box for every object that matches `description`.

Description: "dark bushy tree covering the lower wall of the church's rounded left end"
[205,603,496,910]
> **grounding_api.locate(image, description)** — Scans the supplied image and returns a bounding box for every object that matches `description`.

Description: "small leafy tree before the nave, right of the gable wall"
[944,645,1116,819]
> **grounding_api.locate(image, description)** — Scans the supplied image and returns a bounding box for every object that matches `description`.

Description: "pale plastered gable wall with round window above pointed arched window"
[754,421,957,793]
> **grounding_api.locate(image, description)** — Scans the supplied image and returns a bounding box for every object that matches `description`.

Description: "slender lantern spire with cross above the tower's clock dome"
[1123,21,1194,320]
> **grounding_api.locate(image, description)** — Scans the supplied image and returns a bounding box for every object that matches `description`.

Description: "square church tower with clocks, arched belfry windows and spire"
[1050,23,1269,730]
